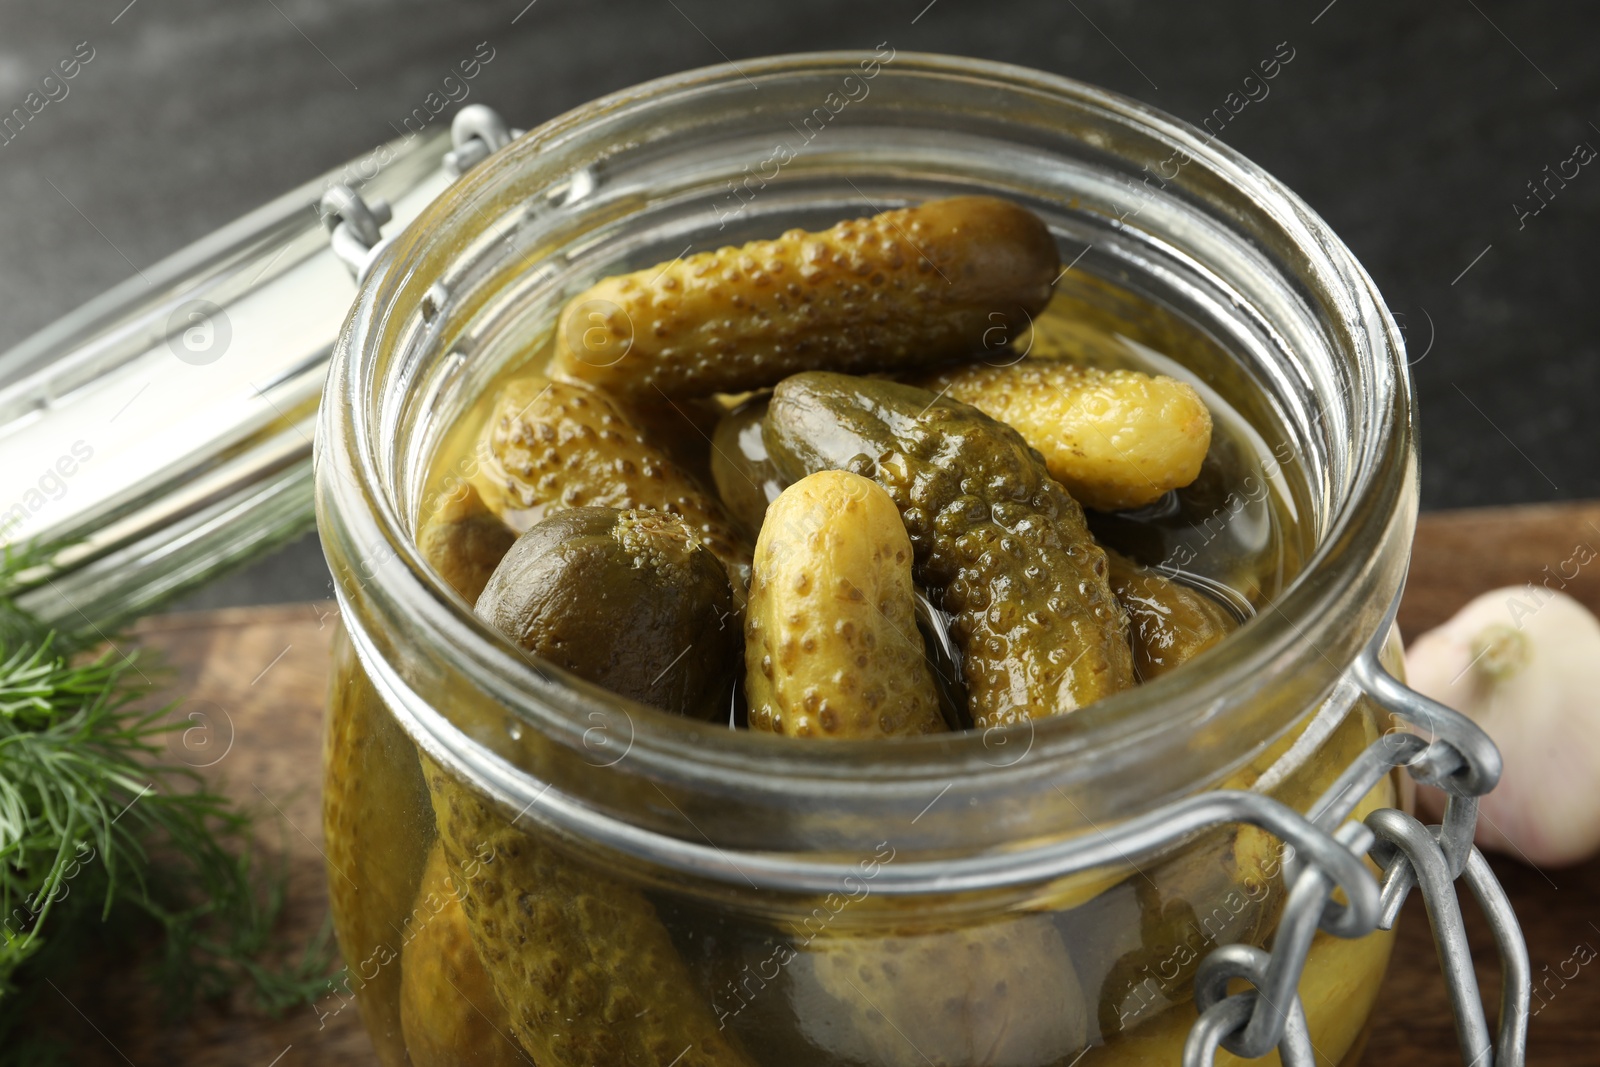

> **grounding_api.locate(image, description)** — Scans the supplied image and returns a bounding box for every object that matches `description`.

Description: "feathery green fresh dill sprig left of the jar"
[0,549,331,1059]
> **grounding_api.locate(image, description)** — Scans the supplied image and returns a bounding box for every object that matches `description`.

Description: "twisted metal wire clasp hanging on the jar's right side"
[1184,598,1531,1067]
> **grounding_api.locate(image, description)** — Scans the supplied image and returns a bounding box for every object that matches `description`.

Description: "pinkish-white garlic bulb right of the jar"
[1405,585,1600,865]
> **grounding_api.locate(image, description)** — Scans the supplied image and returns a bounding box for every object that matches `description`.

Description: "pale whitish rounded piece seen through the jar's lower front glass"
[792,915,1088,1067]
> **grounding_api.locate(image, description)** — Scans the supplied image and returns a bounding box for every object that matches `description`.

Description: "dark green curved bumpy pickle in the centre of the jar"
[763,373,1134,728]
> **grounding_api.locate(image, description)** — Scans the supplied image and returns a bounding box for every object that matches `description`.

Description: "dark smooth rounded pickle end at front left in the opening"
[477,507,744,718]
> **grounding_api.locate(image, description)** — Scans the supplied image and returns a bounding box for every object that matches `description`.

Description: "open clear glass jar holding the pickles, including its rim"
[317,45,1416,1067]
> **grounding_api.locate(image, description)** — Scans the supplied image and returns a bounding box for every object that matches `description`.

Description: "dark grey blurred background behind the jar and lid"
[0,0,1600,606]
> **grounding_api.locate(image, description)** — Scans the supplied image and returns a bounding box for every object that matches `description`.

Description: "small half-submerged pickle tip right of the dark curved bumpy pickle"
[1106,549,1238,681]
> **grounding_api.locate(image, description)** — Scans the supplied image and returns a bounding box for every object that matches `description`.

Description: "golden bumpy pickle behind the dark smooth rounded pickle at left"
[472,378,750,595]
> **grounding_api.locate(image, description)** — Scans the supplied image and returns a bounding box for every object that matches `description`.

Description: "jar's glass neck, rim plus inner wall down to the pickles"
[318,53,1416,851]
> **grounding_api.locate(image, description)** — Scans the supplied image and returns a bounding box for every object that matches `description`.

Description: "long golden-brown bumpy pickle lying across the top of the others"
[550,197,1059,397]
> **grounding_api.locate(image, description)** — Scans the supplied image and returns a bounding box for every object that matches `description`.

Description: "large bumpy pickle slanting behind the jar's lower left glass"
[424,758,750,1067]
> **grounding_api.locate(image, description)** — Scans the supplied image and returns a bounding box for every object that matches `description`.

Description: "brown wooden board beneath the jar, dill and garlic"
[42,502,1600,1067]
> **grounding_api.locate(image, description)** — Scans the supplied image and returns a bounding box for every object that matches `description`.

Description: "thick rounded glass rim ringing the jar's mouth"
[317,51,1416,870]
